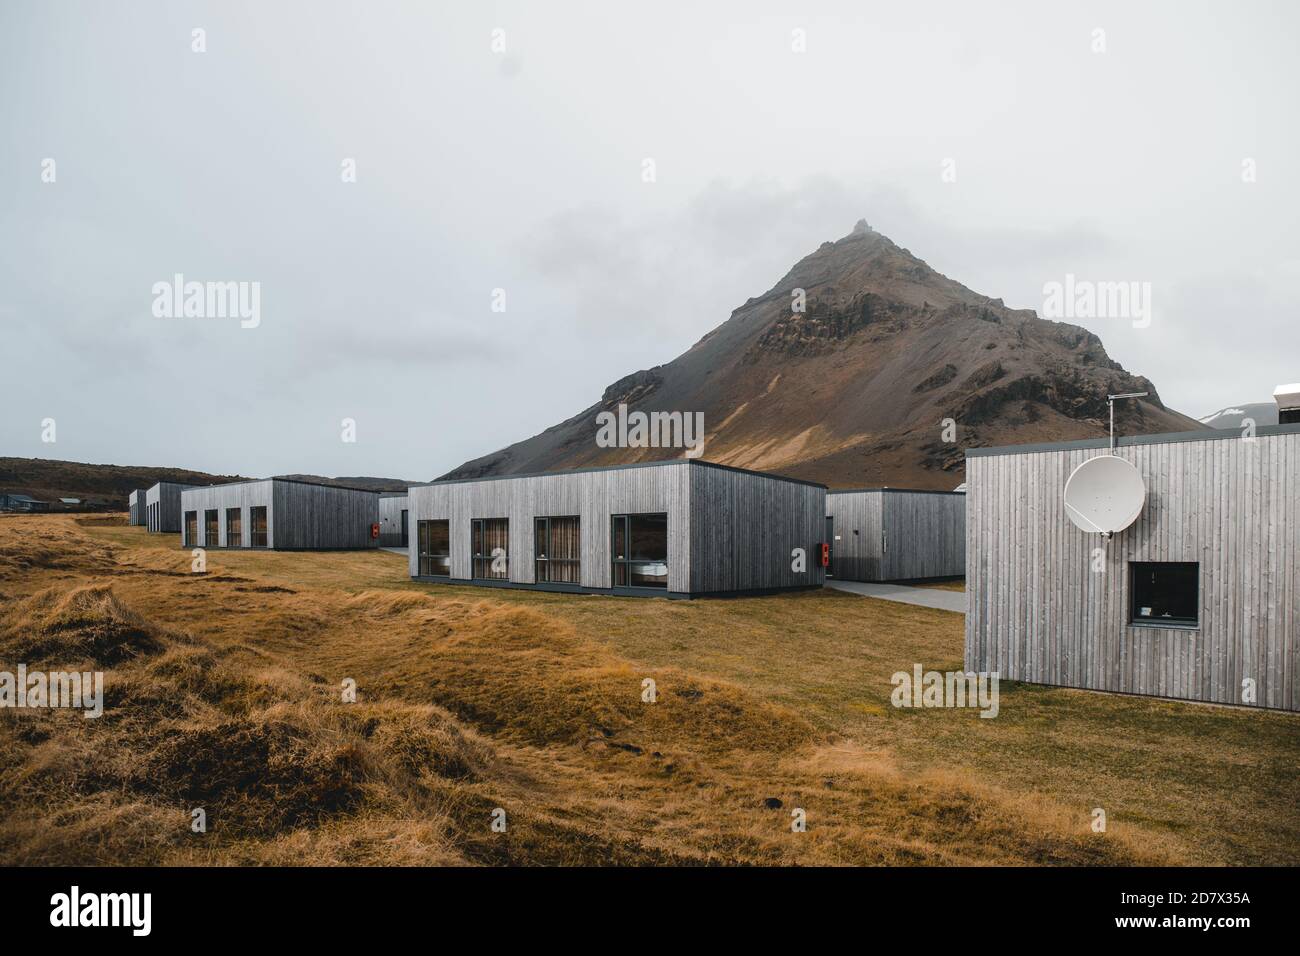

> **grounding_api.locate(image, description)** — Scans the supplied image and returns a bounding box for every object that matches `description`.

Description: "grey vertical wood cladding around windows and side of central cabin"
[408,460,826,594]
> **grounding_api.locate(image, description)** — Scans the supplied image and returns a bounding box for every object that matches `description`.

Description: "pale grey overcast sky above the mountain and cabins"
[0,0,1300,480]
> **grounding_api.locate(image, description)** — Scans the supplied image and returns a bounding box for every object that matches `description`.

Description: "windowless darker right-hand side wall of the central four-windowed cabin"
[690,467,826,594]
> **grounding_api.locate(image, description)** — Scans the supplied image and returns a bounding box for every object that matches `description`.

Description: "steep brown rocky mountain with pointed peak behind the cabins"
[445,221,1200,489]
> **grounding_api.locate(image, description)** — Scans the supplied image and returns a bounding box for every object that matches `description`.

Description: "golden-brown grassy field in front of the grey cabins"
[0,515,1300,865]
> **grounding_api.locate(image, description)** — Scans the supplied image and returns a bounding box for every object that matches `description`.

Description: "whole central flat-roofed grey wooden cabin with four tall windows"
[407,459,826,597]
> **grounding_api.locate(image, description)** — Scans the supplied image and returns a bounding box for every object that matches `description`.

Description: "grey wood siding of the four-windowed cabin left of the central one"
[181,479,380,550]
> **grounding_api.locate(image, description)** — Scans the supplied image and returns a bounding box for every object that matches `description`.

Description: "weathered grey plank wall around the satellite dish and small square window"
[966,429,1300,710]
